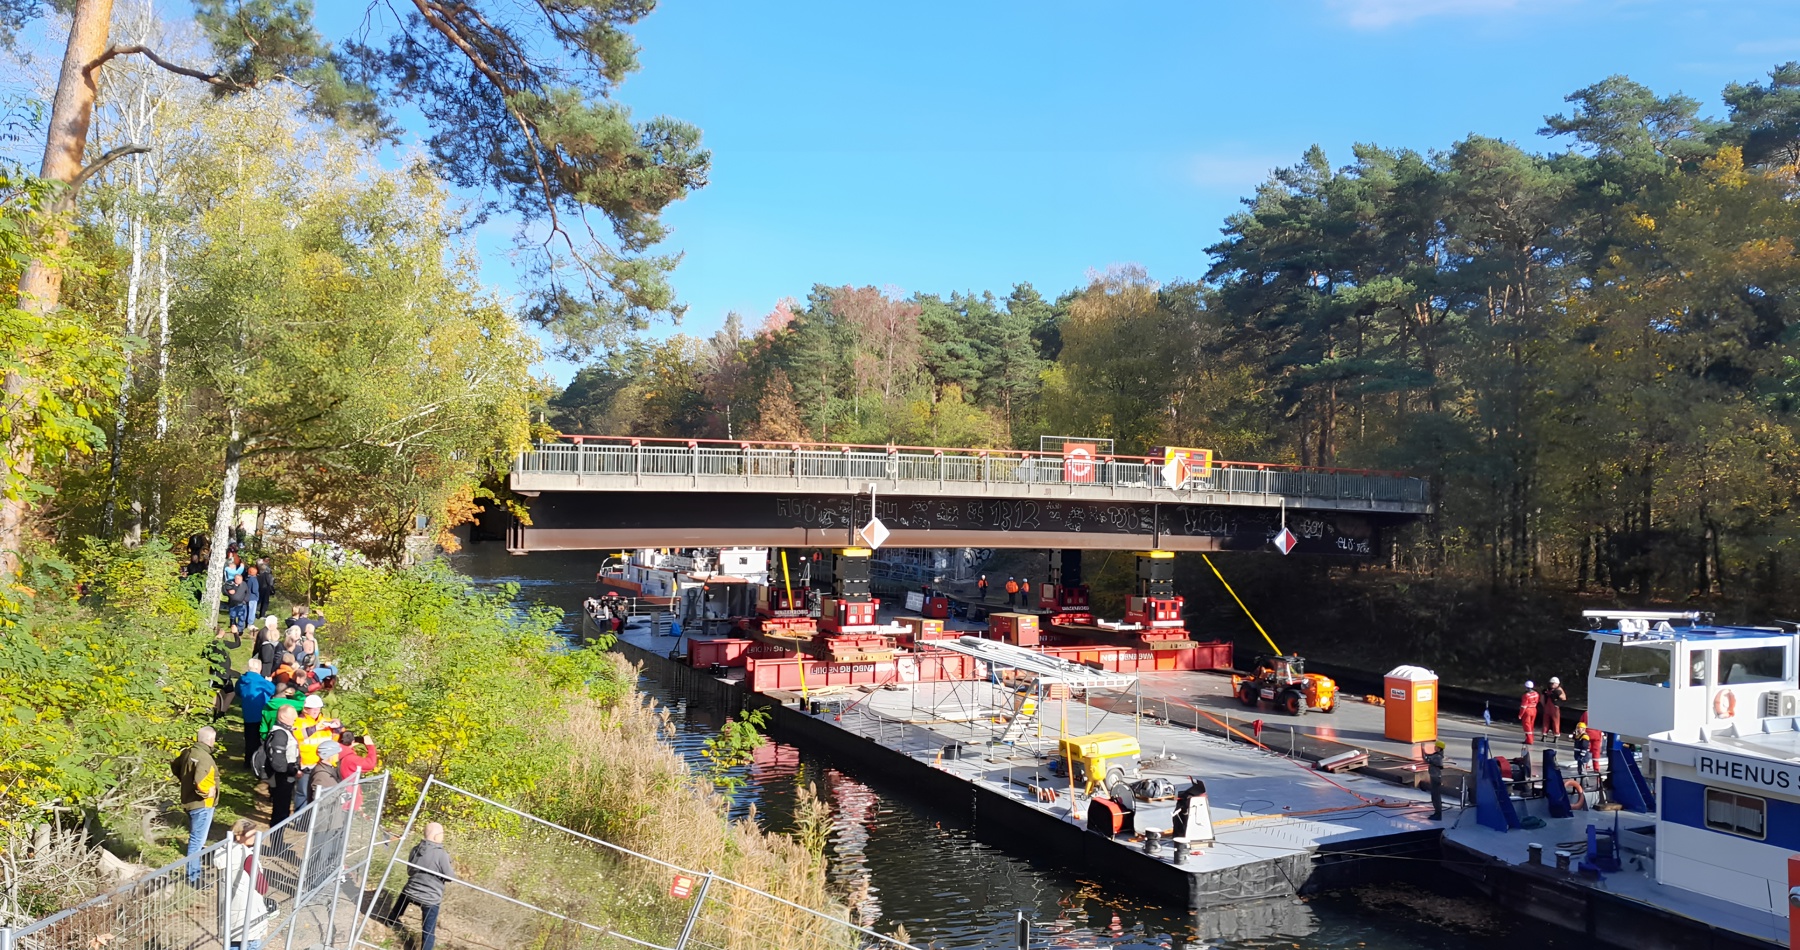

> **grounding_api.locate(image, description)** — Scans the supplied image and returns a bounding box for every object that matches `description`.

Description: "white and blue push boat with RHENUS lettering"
[1444,610,1800,946]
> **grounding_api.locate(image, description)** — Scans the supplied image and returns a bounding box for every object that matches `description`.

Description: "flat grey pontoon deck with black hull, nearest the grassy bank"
[604,624,1438,937]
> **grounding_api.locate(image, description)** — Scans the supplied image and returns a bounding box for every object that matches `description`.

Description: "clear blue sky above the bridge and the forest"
[525,0,1800,376]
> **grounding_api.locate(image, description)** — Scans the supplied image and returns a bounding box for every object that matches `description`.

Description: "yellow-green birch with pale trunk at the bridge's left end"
[173,94,536,626]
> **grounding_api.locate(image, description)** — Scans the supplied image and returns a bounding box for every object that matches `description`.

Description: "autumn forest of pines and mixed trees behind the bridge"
[551,72,1800,599]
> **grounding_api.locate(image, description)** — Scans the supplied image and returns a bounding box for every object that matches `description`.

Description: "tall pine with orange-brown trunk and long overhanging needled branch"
[0,0,711,576]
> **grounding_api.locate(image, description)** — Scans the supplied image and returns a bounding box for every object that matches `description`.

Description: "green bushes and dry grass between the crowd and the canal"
[311,563,857,950]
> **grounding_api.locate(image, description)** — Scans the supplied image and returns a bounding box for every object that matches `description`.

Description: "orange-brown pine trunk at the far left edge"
[0,0,112,578]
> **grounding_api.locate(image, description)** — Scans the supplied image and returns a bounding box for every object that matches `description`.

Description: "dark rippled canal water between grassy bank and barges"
[450,543,1575,950]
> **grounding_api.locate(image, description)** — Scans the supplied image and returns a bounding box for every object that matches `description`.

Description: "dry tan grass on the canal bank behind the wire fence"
[406,660,885,950]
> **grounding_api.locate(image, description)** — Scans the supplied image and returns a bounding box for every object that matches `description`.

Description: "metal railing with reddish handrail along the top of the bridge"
[513,435,1431,506]
